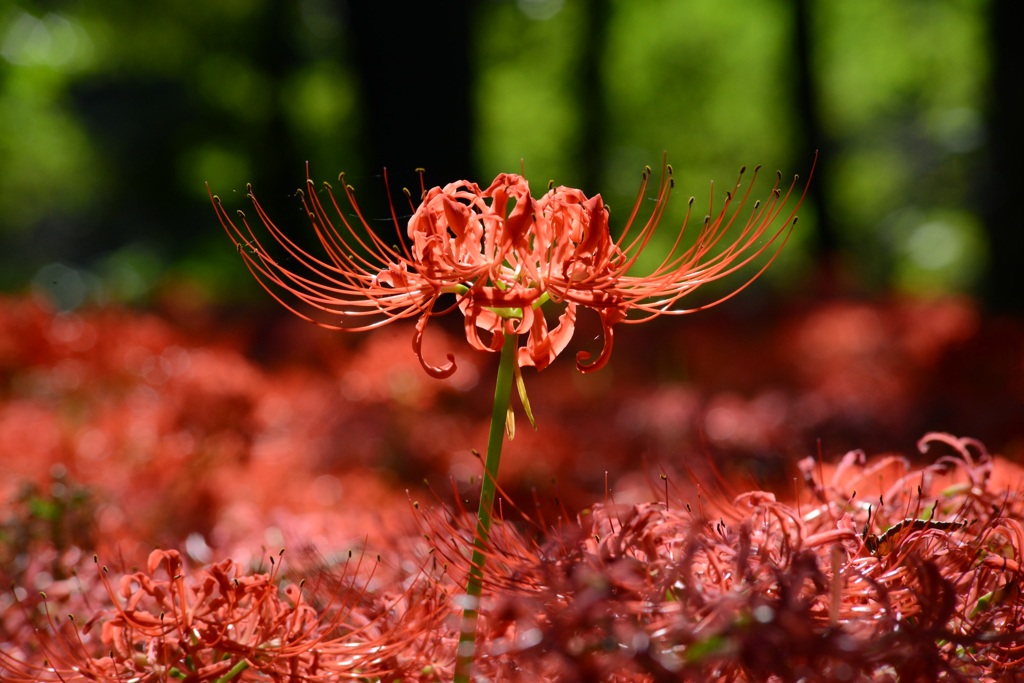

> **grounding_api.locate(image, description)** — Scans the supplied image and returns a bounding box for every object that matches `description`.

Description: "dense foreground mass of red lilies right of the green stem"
[405,433,1024,682]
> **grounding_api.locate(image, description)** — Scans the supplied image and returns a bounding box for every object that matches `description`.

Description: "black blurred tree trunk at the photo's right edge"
[984,0,1024,313]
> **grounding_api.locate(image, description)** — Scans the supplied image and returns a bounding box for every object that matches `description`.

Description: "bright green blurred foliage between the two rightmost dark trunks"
[814,0,990,291]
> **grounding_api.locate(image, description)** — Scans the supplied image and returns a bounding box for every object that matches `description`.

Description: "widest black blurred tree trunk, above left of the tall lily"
[348,0,477,205]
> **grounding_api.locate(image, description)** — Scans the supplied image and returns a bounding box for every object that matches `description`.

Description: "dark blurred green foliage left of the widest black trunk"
[0,0,358,307]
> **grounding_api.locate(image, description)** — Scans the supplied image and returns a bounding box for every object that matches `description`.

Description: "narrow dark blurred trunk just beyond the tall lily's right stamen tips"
[792,0,841,296]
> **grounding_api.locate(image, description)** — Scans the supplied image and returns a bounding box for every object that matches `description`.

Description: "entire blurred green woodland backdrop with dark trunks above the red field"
[0,0,1024,309]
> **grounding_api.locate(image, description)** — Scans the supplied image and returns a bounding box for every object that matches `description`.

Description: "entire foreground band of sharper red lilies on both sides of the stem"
[6,433,1024,683]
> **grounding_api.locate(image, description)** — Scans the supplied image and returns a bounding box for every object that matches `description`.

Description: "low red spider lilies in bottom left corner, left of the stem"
[0,550,447,683]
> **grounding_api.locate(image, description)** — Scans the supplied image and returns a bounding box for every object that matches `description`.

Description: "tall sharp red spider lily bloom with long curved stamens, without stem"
[211,165,806,378]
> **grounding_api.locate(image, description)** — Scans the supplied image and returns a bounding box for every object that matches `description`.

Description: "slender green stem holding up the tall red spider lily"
[455,335,518,683]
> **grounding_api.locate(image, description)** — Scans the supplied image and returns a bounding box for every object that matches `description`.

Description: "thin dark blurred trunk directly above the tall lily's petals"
[577,0,611,195]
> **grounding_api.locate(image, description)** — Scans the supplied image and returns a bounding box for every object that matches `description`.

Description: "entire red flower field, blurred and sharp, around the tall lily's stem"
[0,298,1024,681]
